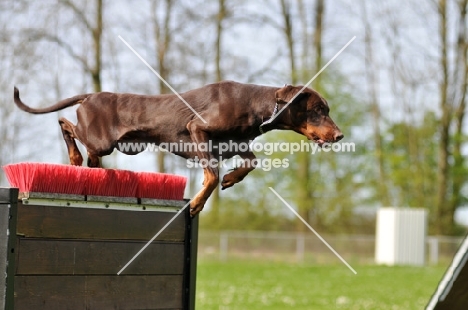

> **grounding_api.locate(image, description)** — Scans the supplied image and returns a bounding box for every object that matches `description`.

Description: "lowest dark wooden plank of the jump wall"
[15,275,183,310]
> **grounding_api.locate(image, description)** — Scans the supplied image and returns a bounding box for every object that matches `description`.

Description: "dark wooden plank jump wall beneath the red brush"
[0,188,198,310]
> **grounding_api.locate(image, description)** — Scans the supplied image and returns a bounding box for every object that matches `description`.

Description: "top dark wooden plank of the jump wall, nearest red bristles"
[16,203,186,241]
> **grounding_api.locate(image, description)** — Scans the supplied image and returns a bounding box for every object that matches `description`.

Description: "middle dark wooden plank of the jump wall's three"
[16,238,185,275]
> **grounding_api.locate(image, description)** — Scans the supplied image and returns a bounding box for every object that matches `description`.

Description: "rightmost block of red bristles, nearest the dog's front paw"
[137,172,187,200]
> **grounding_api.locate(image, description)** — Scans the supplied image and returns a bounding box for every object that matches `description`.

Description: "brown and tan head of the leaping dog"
[276,85,343,145]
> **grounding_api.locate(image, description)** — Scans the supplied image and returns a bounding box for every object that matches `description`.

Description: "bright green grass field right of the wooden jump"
[196,261,446,310]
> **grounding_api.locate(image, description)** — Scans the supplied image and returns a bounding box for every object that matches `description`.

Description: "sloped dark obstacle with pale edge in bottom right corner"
[426,235,468,310]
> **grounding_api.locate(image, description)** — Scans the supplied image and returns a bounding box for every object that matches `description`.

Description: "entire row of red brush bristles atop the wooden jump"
[3,163,187,200]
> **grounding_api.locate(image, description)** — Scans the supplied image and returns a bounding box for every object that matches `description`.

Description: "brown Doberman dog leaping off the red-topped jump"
[14,81,343,215]
